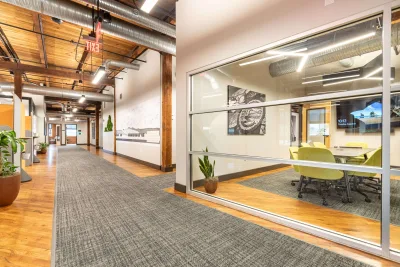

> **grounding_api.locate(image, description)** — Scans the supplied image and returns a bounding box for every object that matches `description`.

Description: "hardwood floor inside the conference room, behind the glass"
[192,167,400,249]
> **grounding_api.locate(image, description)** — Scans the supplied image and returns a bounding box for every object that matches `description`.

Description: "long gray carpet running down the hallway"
[53,147,368,267]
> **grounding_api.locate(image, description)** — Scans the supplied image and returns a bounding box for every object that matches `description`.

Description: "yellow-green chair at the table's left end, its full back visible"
[298,147,344,206]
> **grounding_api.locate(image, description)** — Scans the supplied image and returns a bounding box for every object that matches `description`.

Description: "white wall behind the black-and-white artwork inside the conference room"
[192,70,290,180]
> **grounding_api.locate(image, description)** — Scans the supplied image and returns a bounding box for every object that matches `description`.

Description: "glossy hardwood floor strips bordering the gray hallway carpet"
[0,145,400,267]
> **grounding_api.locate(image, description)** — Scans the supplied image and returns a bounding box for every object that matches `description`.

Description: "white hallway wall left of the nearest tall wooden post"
[115,50,161,165]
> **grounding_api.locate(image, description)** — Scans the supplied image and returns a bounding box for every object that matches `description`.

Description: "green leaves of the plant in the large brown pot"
[0,131,26,178]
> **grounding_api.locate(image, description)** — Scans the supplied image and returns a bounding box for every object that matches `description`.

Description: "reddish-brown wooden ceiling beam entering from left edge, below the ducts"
[0,61,114,86]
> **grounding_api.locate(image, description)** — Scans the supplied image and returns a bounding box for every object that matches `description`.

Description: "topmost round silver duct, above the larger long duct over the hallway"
[81,0,176,38]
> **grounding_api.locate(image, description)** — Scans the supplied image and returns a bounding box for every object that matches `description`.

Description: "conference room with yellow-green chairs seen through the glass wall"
[189,11,400,253]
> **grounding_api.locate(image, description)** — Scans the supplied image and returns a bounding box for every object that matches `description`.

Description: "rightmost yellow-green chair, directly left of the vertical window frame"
[347,148,382,203]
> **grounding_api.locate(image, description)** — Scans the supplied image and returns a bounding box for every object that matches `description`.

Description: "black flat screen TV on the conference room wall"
[336,95,400,133]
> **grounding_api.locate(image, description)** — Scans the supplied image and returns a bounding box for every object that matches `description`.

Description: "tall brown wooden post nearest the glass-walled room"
[161,54,173,171]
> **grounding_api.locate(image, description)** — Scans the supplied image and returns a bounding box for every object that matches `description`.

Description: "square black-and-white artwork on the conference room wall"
[228,85,266,135]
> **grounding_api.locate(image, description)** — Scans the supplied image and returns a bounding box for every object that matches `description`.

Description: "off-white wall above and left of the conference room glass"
[176,0,391,185]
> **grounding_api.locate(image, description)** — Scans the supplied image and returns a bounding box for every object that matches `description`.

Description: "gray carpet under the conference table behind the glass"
[239,169,400,225]
